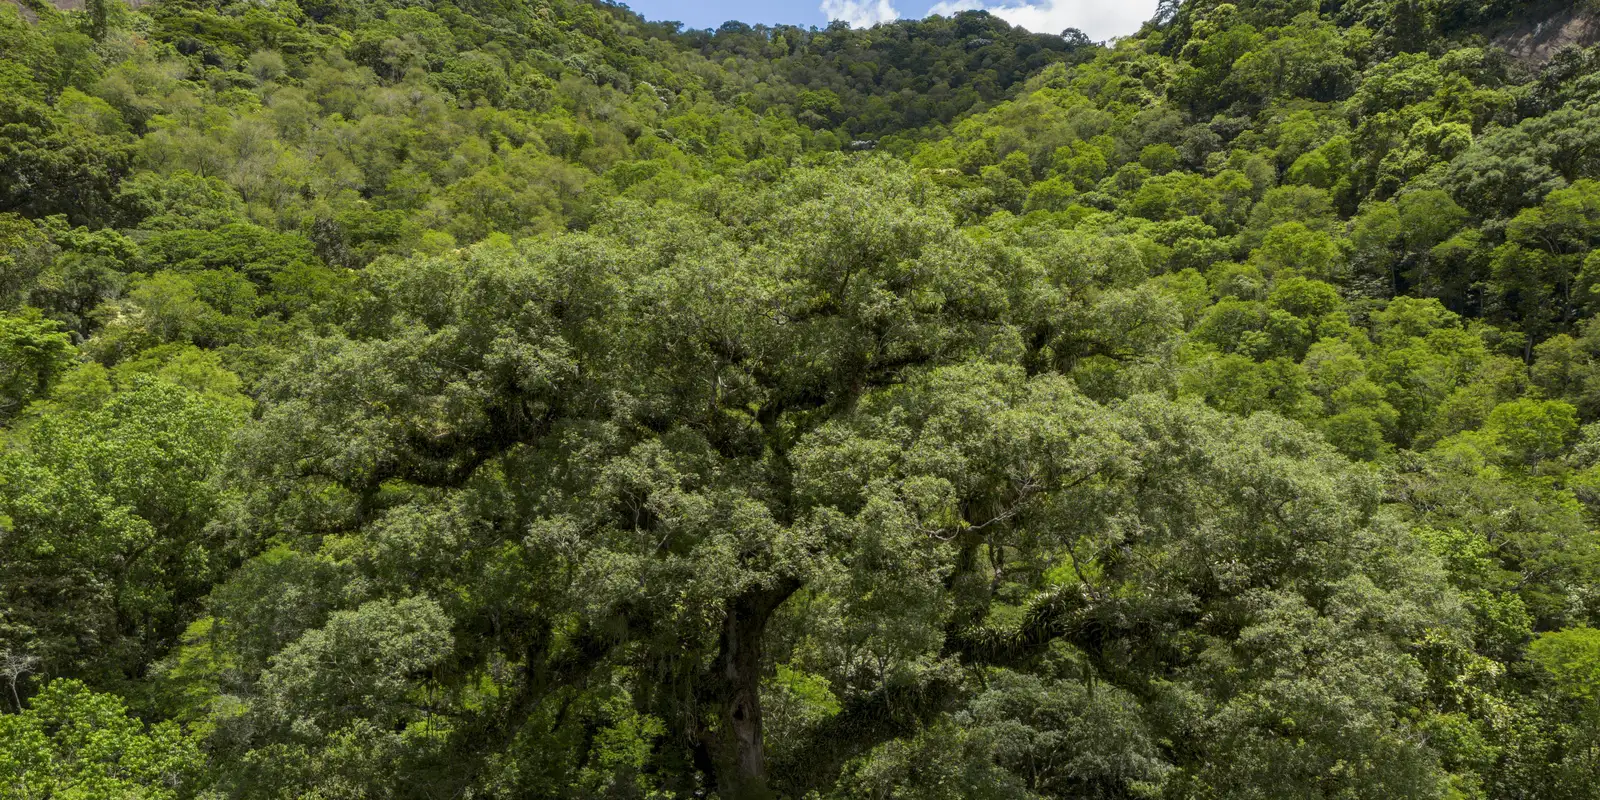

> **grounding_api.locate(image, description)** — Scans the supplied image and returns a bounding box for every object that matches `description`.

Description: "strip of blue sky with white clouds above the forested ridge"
[622,0,1157,40]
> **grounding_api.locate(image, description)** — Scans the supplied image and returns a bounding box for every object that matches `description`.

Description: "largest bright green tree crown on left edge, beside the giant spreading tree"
[0,378,242,680]
